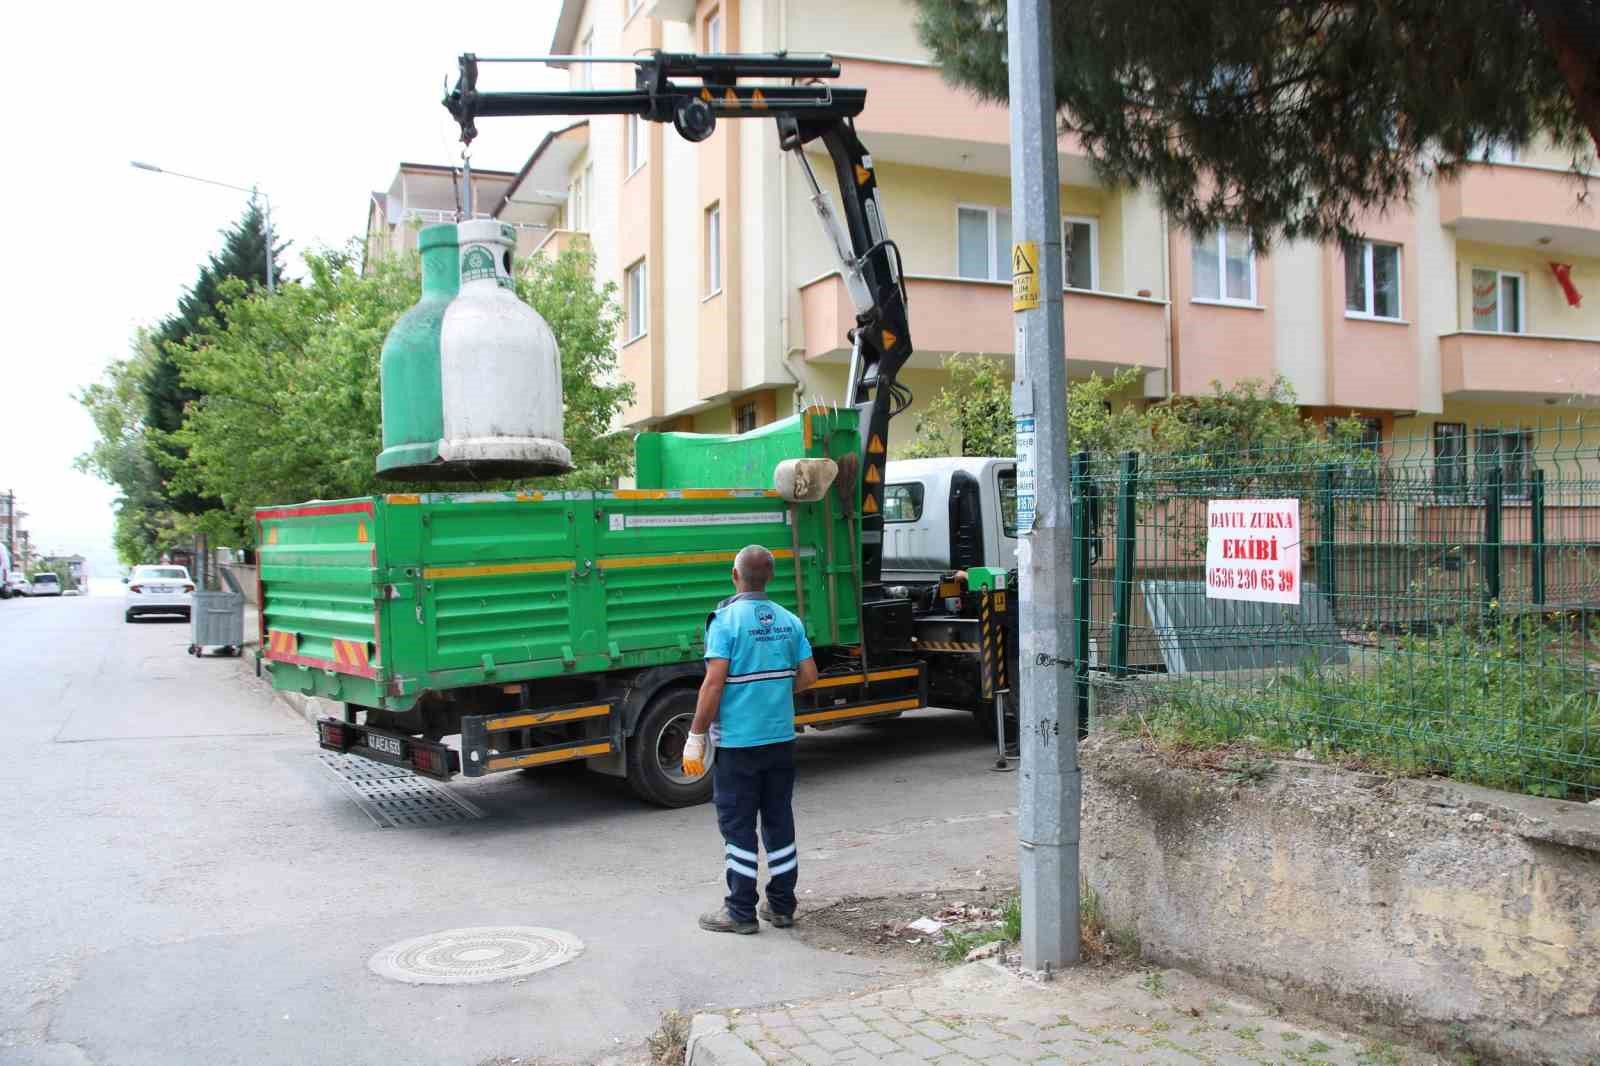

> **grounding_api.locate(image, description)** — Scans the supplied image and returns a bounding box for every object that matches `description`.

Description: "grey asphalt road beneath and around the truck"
[0,585,1016,1066]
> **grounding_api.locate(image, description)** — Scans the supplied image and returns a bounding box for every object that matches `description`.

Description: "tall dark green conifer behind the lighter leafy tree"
[142,198,288,514]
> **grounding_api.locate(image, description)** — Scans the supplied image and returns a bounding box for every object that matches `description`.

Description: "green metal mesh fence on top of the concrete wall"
[1072,423,1600,800]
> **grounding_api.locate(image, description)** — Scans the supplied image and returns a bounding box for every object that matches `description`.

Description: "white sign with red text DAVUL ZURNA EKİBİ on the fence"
[1205,499,1301,603]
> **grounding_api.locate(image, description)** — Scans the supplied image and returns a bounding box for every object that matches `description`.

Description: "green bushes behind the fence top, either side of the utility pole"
[906,355,1360,467]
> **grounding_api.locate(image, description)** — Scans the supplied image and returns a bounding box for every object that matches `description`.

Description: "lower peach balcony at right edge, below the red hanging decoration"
[1438,331,1600,403]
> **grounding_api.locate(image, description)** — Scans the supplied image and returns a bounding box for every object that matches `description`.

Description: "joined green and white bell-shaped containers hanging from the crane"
[378,219,573,480]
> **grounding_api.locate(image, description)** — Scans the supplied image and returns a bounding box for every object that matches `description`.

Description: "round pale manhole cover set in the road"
[368,925,584,984]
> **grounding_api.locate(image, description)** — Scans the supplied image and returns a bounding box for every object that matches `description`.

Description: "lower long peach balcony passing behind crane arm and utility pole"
[800,272,1166,375]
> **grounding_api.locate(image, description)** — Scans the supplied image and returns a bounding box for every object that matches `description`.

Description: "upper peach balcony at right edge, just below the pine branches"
[1438,163,1600,256]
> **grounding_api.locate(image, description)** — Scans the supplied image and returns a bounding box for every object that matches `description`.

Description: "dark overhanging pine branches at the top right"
[917,0,1600,246]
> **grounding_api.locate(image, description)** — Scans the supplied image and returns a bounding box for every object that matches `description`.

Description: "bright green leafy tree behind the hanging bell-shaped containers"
[171,240,632,544]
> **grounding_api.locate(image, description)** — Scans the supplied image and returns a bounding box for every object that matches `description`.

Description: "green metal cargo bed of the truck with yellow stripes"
[256,408,861,712]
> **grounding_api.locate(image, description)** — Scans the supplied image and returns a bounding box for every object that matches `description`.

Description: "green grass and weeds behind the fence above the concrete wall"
[1118,618,1600,799]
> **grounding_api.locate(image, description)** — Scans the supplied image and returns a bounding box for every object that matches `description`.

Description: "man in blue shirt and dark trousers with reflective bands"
[683,544,816,933]
